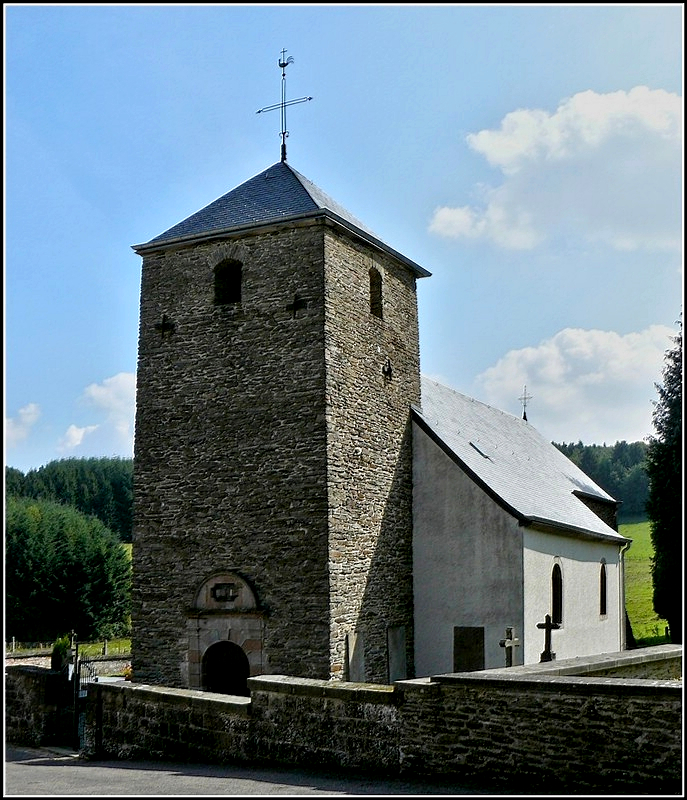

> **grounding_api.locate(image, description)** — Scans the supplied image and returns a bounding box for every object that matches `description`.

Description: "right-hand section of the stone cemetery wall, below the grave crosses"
[400,673,682,794]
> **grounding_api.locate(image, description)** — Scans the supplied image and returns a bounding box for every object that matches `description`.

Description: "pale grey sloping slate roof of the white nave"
[413,376,627,544]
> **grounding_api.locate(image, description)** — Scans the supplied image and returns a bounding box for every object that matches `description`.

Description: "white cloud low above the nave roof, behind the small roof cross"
[476,325,675,444]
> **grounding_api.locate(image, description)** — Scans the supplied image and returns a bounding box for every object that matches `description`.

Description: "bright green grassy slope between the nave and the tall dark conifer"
[619,522,668,645]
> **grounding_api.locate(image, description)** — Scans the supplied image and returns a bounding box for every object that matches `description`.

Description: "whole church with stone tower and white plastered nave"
[132,153,629,694]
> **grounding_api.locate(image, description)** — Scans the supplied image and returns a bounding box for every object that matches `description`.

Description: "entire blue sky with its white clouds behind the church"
[4,4,683,471]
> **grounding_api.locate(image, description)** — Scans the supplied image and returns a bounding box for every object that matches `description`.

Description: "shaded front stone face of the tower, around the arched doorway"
[132,226,329,686]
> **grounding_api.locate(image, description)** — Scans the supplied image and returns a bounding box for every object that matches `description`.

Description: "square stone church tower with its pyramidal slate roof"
[132,160,429,693]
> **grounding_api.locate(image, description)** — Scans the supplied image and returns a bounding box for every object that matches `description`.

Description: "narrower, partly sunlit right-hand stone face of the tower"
[325,231,420,683]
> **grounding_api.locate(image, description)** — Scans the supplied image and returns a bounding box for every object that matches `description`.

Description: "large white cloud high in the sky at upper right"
[429,86,682,250]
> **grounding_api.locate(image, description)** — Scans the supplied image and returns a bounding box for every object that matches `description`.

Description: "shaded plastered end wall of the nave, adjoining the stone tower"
[413,424,523,677]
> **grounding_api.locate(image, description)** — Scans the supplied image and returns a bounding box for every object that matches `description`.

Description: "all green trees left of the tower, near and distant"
[5,458,133,642]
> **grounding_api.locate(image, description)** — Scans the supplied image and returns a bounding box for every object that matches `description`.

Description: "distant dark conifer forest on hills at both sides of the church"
[5,441,649,542]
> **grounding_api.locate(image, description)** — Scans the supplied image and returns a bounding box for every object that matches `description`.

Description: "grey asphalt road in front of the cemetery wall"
[3,745,510,797]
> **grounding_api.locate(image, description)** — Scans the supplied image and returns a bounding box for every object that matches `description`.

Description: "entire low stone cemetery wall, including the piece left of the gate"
[6,645,682,794]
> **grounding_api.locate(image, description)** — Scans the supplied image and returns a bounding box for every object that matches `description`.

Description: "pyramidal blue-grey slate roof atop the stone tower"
[133,161,431,277]
